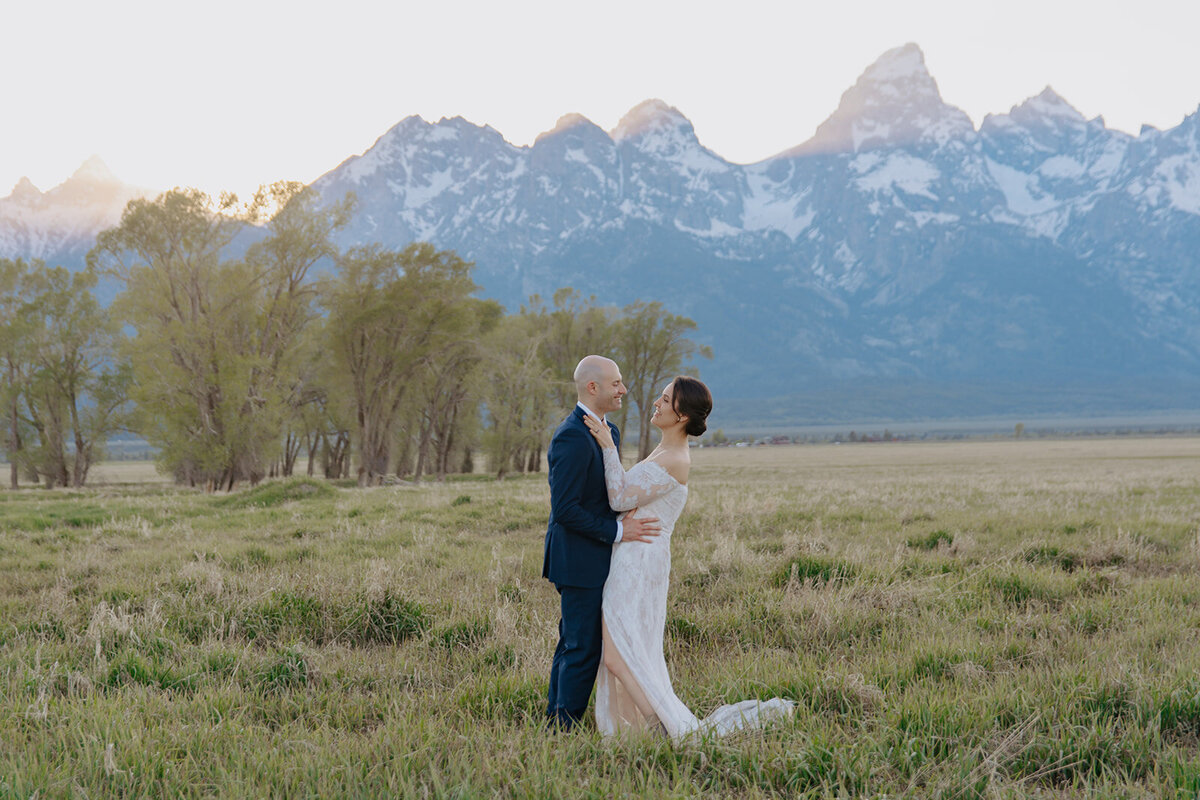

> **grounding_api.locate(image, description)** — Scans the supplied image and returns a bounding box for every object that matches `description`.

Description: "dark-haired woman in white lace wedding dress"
[584,375,793,740]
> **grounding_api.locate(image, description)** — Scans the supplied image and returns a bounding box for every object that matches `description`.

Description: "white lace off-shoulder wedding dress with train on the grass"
[596,447,793,740]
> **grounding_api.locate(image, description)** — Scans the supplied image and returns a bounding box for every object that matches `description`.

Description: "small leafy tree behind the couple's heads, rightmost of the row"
[616,301,713,459]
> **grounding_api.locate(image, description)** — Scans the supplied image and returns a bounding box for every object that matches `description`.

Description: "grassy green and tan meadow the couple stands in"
[0,438,1200,798]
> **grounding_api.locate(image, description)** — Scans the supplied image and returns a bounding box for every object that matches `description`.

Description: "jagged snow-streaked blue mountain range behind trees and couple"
[0,44,1200,415]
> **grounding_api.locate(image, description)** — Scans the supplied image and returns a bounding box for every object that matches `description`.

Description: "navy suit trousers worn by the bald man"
[546,584,604,730]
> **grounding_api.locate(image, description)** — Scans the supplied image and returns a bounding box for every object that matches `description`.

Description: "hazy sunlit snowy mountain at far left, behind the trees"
[0,156,150,267]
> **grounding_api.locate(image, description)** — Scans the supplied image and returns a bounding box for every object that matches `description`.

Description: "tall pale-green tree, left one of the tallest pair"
[88,190,247,491]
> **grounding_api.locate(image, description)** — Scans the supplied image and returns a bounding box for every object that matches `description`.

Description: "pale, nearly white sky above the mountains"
[0,0,1200,197]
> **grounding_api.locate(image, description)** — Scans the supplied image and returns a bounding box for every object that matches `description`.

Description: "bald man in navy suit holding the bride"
[541,355,659,730]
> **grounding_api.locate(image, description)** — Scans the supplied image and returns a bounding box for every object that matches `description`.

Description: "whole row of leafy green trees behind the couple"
[0,182,712,491]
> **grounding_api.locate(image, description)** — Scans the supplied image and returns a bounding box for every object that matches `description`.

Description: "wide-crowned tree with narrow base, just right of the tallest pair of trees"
[322,243,476,486]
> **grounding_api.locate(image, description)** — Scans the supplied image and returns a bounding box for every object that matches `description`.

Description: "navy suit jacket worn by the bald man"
[541,405,620,589]
